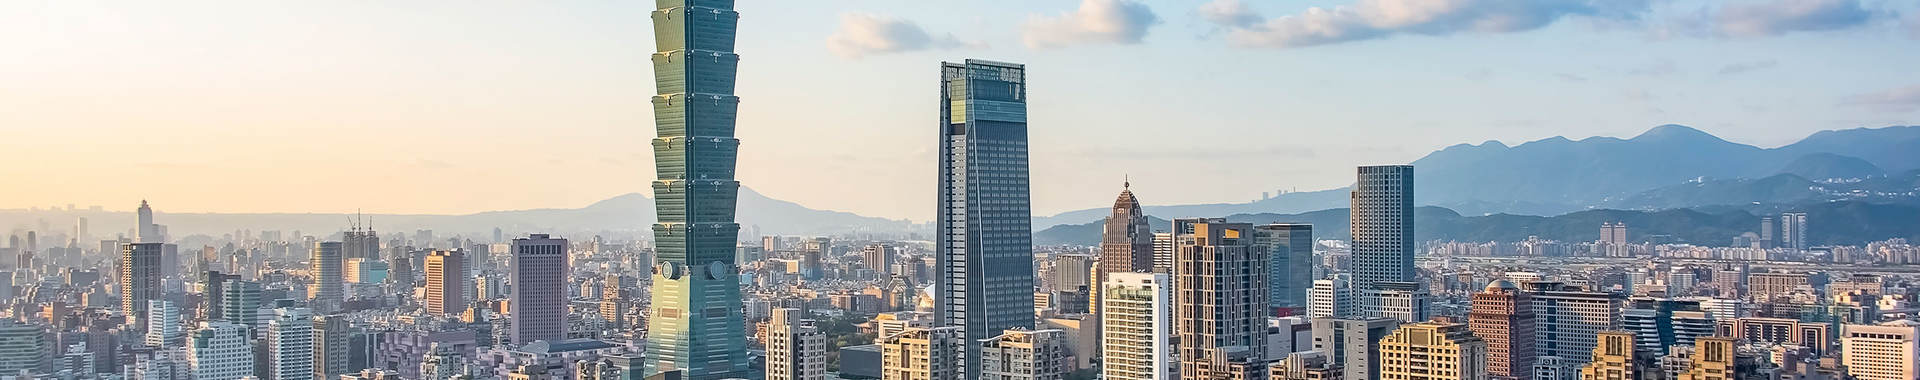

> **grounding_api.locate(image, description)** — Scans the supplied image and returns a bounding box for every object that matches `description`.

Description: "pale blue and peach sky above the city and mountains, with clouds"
[0,0,1920,221]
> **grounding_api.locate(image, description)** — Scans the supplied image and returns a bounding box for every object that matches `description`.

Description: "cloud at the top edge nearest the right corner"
[1715,0,1874,36]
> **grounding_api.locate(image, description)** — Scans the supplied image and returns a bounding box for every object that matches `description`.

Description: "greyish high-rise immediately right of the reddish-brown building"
[1526,282,1620,378]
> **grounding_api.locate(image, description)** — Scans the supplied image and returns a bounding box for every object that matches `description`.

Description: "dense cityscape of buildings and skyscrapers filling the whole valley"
[0,0,1920,380]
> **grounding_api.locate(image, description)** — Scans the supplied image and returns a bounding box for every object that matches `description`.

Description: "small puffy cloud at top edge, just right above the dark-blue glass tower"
[1021,0,1160,48]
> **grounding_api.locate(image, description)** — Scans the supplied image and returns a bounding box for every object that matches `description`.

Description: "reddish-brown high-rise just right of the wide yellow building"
[1467,280,1536,380]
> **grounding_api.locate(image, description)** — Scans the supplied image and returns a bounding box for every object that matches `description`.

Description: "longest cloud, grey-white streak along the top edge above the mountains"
[1231,0,1649,48]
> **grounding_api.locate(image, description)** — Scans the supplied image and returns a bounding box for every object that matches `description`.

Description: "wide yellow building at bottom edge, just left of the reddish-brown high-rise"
[1380,322,1488,380]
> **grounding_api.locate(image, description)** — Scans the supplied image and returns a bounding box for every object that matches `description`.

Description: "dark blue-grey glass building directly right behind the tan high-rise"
[1254,225,1313,307]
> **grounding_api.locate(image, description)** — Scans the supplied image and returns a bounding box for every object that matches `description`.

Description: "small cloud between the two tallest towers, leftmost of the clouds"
[828,13,981,58]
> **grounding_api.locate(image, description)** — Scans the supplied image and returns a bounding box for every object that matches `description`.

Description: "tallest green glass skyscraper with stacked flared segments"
[645,0,749,380]
